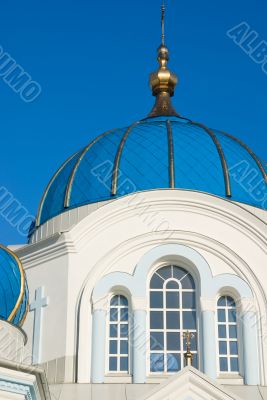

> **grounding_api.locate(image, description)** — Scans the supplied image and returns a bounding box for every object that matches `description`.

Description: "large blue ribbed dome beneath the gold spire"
[37,117,267,226]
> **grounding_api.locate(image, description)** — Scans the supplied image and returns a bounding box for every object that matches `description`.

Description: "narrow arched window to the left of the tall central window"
[108,295,129,373]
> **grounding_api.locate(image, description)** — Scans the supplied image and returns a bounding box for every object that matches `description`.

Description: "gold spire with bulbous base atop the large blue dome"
[149,1,179,117]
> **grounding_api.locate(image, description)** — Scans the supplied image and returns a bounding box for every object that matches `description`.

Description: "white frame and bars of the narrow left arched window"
[105,292,131,376]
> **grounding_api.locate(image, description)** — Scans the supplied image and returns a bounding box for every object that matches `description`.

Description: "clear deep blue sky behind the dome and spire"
[0,0,267,244]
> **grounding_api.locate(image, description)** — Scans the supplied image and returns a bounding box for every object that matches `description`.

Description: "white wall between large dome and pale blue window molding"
[17,190,267,384]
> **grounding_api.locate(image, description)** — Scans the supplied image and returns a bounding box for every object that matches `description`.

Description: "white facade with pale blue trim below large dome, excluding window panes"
[12,189,267,400]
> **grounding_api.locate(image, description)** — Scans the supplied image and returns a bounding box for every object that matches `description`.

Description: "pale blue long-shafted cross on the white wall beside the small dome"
[30,287,48,364]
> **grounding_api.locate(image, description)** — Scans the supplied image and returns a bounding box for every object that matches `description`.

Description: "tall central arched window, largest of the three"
[150,265,198,373]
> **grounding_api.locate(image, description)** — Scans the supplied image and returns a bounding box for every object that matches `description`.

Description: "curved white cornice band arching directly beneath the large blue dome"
[71,189,267,252]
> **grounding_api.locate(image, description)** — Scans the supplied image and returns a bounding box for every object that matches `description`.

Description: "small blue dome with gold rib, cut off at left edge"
[0,245,29,326]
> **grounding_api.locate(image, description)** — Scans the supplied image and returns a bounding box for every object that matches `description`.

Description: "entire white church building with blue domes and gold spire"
[0,3,267,400]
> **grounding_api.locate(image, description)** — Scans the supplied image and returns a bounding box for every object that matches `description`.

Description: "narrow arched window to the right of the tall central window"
[217,296,239,373]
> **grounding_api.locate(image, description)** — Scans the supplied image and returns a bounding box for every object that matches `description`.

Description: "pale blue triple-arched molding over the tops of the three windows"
[92,244,253,304]
